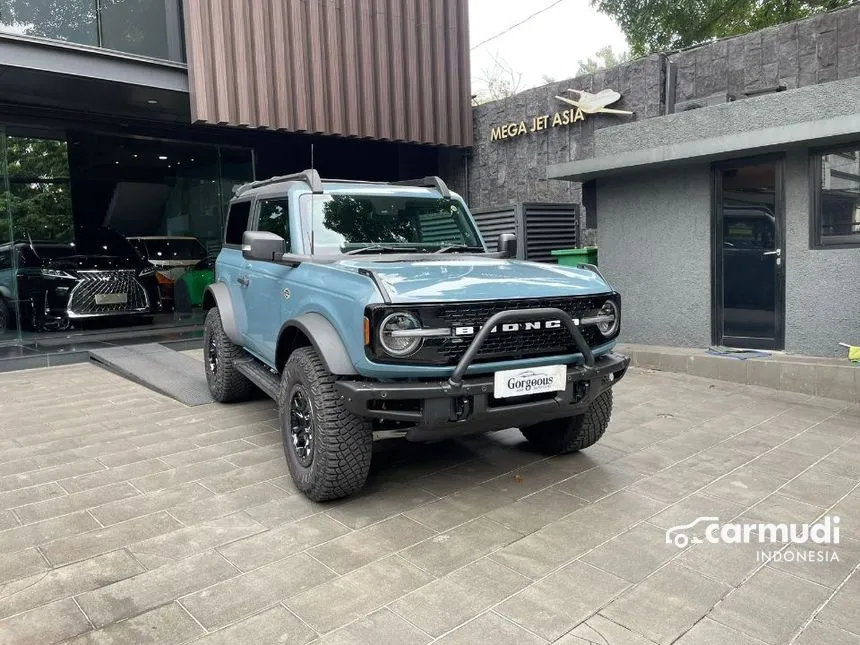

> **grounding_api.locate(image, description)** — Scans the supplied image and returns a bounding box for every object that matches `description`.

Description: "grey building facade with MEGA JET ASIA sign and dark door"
[467,5,860,356]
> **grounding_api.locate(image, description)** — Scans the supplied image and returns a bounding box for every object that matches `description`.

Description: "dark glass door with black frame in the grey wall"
[712,157,785,349]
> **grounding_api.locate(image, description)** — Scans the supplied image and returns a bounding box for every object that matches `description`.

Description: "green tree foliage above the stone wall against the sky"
[591,0,853,56]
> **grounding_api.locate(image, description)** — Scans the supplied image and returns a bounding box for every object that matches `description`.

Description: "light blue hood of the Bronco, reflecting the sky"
[339,256,612,302]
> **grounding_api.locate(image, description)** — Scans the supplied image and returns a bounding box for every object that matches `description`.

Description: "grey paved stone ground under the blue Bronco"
[0,358,860,645]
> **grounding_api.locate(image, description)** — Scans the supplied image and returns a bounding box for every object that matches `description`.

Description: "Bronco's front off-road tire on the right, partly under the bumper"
[520,390,612,455]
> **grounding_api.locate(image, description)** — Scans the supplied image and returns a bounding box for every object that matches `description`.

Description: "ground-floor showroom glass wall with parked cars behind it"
[0,125,254,344]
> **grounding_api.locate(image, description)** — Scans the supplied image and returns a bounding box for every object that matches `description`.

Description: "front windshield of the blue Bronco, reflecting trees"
[304,194,484,255]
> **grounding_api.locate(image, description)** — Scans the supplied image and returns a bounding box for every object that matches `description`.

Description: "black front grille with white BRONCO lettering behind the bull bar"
[371,294,617,365]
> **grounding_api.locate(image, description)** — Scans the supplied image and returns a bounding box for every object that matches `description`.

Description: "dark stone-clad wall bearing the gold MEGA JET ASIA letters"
[464,5,860,226]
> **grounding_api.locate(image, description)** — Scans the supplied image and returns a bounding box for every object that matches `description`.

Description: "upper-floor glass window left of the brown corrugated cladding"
[0,0,185,61]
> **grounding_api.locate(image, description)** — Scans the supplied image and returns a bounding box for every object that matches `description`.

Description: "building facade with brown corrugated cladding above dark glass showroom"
[0,0,472,367]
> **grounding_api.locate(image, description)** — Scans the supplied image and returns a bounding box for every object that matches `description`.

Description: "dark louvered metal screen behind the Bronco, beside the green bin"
[472,202,579,262]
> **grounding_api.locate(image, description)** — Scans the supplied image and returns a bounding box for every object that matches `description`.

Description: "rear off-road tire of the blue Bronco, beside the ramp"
[203,307,254,403]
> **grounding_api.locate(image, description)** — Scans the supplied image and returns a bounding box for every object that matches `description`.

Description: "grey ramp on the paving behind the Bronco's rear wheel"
[90,343,213,405]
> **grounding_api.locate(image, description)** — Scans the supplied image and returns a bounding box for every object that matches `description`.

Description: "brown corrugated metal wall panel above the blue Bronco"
[184,0,472,146]
